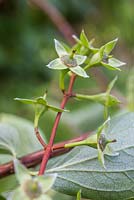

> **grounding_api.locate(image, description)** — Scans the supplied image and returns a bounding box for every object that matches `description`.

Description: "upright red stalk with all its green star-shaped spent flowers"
[12,31,125,200]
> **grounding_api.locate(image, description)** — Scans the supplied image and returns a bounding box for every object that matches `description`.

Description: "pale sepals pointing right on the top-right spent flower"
[101,58,126,71]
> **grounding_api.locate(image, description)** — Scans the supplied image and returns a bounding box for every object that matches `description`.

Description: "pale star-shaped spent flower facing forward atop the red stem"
[47,40,89,78]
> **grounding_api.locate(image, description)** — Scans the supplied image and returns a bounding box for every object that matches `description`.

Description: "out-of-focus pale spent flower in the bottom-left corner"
[12,159,56,200]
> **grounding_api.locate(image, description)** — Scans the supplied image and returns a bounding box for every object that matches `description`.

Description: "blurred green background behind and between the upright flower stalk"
[0,0,134,199]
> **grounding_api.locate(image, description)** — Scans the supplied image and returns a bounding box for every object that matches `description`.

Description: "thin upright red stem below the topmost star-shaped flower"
[39,74,76,175]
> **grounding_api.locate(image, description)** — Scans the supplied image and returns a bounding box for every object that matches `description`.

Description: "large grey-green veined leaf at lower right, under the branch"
[47,113,134,200]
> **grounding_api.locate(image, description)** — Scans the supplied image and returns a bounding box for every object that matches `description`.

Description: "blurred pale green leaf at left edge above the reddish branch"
[0,114,44,164]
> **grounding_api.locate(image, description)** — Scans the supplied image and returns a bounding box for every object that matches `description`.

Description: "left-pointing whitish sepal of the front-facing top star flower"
[47,58,68,70]
